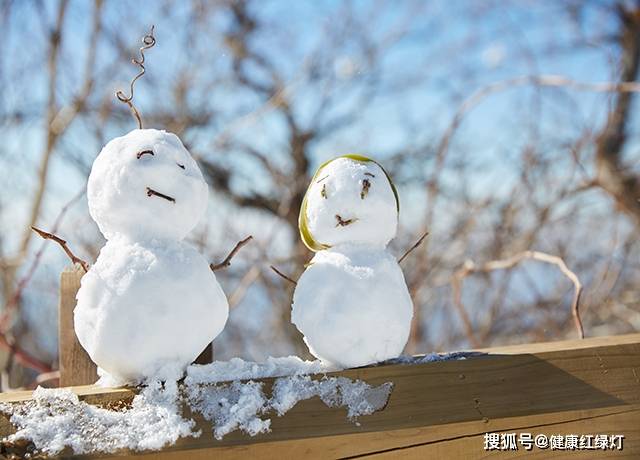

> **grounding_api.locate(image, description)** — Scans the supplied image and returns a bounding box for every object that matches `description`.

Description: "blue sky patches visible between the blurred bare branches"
[0,0,637,358]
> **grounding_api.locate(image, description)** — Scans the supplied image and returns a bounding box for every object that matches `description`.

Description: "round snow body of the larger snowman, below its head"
[74,239,228,383]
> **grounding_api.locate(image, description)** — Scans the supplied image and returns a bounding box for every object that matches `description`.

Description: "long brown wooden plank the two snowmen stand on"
[0,334,640,459]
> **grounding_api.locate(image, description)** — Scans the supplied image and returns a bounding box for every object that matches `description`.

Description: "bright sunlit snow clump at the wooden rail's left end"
[0,382,199,455]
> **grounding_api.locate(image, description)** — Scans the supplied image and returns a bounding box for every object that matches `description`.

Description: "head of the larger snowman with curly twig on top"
[87,129,208,240]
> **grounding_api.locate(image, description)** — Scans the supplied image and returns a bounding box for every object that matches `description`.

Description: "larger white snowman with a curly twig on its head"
[74,129,229,383]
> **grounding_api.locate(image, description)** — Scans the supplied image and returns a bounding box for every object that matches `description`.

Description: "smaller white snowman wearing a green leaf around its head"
[291,155,413,367]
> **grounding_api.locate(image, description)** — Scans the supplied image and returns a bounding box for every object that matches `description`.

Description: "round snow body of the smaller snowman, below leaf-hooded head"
[291,245,413,367]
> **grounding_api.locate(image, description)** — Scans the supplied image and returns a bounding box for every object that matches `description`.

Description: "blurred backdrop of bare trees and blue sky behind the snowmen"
[0,0,640,384]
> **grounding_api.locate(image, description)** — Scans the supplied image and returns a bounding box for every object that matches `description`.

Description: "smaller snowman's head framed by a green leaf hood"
[298,155,400,251]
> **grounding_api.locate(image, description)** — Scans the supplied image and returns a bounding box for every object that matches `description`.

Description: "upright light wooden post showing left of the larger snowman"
[58,266,98,387]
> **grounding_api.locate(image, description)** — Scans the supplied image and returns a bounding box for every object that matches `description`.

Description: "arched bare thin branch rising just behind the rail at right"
[451,251,584,346]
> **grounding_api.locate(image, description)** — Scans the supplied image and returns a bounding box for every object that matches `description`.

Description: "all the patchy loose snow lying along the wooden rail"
[0,353,469,455]
